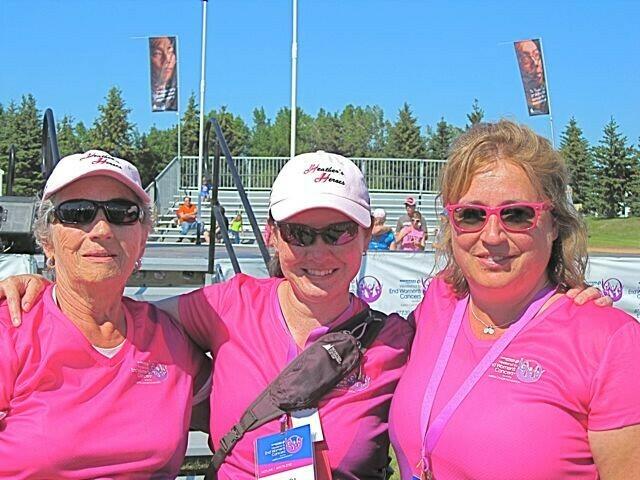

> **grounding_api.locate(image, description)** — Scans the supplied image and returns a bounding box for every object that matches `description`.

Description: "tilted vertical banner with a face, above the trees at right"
[514,38,549,116]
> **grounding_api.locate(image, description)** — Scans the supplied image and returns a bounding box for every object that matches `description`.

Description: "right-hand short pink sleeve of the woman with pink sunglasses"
[588,322,640,431]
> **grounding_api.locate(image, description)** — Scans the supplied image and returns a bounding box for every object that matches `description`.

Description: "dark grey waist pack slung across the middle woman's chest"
[205,307,388,480]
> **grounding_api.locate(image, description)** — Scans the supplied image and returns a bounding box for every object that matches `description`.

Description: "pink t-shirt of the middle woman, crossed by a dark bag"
[180,274,413,480]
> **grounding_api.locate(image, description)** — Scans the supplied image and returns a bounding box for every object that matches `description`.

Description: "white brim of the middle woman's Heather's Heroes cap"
[270,195,371,228]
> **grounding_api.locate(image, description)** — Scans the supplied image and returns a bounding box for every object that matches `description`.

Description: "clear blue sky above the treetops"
[0,0,640,144]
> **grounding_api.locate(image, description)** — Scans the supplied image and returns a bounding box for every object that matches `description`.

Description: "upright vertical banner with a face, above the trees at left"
[149,37,178,112]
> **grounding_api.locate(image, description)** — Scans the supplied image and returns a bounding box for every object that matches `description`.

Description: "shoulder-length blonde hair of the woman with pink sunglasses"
[437,120,588,296]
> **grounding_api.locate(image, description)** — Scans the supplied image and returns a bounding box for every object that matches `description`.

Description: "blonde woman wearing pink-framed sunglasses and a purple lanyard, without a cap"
[390,121,640,480]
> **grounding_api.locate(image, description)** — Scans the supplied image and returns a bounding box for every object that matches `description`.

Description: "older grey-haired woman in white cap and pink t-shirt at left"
[0,150,210,479]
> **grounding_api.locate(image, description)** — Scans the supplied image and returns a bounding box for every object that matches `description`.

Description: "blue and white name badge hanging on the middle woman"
[255,425,316,480]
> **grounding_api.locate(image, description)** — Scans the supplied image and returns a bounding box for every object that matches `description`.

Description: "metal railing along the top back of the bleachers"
[176,157,445,193]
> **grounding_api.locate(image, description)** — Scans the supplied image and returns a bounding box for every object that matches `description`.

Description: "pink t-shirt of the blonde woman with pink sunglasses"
[390,279,640,480]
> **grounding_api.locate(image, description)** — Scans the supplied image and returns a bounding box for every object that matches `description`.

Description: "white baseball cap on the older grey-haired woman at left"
[42,150,151,203]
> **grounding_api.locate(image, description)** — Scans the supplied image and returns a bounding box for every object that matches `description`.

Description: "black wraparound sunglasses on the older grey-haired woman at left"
[54,198,142,225]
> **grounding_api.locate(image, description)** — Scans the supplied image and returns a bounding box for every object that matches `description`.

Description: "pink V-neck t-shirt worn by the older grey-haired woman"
[0,287,205,479]
